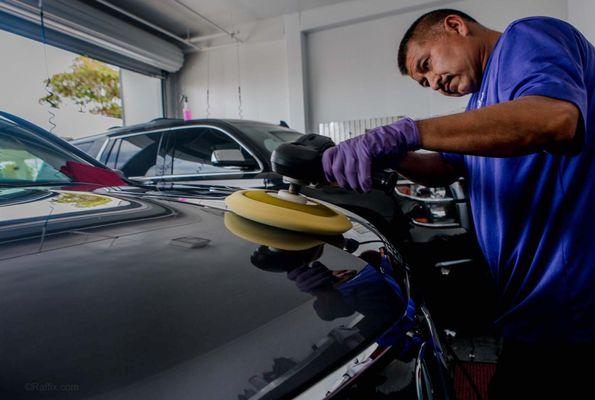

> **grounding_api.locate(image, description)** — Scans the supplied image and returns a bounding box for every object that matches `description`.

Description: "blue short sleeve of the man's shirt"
[498,17,588,133]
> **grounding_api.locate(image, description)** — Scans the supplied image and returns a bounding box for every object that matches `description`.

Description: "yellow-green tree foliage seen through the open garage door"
[39,56,122,118]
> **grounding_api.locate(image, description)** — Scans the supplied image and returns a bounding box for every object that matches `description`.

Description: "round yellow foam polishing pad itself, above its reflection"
[225,190,352,235]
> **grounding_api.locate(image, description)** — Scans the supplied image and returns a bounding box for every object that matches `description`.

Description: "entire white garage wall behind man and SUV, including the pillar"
[179,0,595,132]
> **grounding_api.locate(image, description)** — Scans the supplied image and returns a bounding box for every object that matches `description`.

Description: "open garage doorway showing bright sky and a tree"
[0,29,163,139]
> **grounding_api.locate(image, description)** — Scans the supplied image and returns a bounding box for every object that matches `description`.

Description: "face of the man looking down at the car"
[407,32,481,97]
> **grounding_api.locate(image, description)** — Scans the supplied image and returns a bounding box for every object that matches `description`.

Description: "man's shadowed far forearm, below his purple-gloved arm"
[397,153,460,186]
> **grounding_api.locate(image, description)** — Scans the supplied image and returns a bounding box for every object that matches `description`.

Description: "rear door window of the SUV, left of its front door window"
[106,133,161,177]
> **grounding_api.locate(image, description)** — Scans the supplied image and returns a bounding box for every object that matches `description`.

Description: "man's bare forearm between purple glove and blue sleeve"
[417,96,582,157]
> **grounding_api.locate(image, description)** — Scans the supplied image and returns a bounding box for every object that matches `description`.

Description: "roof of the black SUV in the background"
[71,118,292,144]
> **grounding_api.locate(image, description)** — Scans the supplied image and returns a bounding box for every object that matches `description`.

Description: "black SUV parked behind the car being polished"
[72,118,494,331]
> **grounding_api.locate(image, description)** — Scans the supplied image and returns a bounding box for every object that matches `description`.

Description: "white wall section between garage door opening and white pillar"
[178,39,289,123]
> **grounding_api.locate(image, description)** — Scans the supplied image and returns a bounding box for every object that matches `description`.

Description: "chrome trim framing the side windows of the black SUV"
[97,124,265,181]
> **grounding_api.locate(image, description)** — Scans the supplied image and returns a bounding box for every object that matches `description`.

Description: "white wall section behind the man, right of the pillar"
[306,0,572,132]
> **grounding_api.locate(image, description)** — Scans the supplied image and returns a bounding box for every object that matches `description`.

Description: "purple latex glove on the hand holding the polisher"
[322,118,420,192]
